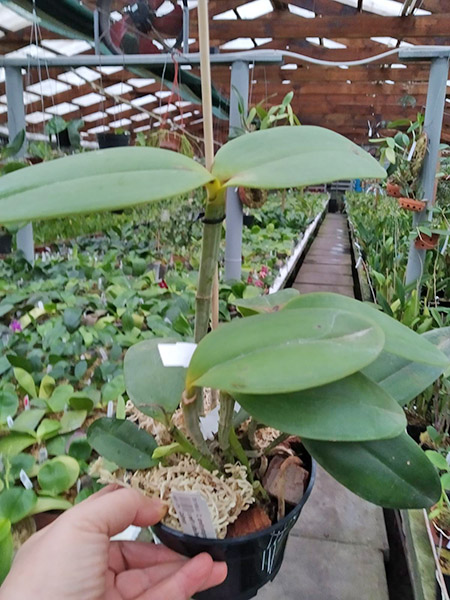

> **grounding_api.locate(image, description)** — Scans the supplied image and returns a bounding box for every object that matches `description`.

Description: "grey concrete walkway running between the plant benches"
[257,214,389,600]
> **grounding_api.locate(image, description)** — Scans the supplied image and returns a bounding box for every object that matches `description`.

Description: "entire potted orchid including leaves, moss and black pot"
[0,16,449,600]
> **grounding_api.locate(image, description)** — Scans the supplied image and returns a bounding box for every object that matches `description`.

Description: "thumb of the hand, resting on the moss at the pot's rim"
[63,488,167,537]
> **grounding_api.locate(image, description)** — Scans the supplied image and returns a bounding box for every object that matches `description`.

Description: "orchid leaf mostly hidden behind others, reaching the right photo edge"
[363,327,450,405]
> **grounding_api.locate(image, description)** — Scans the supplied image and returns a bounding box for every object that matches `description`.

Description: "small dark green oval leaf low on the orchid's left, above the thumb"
[87,417,157,469]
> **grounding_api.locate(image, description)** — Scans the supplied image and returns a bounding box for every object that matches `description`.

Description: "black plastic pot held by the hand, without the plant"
[152,455,316,600]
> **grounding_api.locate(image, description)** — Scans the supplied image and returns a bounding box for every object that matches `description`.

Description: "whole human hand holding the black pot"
[0,486,227,600]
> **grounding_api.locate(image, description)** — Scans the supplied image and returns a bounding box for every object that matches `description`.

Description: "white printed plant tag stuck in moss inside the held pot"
[171,490,217,539]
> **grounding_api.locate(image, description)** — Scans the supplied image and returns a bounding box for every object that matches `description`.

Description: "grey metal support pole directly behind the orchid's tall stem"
[225,61,249,281]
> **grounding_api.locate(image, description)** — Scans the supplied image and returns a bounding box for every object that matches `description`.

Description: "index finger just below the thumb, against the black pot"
[110,542,187,570]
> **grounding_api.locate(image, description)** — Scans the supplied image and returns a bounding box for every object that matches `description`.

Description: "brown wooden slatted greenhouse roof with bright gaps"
[0,0,450,143]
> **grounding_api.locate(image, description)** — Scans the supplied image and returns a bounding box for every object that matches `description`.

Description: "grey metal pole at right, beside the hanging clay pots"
[406,57,449,285]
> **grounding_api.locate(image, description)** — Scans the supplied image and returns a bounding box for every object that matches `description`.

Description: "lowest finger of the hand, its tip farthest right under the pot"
[136,554,227,600]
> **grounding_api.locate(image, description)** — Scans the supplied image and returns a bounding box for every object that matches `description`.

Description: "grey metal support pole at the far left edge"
[5,67,34,264]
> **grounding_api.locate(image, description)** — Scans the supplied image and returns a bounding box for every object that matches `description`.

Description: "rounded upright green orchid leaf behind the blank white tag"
[124,338,186,421]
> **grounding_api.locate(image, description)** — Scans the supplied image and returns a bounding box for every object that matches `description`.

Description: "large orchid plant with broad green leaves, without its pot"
[0,126,449,508]
